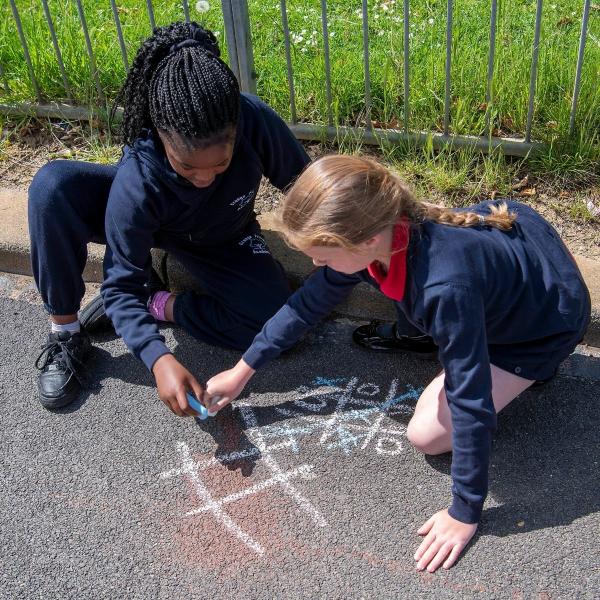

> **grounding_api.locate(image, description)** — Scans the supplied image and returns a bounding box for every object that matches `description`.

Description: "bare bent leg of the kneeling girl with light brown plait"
[406,365,534,454]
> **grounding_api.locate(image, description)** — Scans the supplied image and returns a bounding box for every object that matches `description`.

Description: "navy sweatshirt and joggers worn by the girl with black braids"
[29,94,309,369]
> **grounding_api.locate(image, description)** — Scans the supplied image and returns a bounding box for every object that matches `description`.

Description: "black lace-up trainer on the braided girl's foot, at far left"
[35,330,92,409]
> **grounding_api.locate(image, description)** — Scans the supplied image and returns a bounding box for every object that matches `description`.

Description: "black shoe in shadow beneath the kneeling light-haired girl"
[352,321,438,359]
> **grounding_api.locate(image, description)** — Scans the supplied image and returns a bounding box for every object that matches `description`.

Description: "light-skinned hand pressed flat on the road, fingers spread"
[415,509,477,573]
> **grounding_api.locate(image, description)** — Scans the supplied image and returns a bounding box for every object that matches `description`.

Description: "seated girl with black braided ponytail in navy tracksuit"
[29,23,309,416]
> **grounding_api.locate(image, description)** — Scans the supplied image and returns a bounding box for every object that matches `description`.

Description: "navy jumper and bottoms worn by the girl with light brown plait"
[243,202,590,523]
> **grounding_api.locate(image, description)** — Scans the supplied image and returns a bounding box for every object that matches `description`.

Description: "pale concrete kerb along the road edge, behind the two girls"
[0,189,600,347]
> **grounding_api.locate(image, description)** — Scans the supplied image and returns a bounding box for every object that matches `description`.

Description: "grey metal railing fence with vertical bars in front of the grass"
[0,0,591,156]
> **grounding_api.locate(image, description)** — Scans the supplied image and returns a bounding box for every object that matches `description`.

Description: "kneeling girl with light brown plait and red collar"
[205,156,591,572]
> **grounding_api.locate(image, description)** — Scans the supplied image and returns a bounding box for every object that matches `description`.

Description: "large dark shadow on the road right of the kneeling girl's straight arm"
[426,355,600,537]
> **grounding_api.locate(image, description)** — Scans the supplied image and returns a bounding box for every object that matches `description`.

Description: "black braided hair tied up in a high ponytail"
[113,22,240,149]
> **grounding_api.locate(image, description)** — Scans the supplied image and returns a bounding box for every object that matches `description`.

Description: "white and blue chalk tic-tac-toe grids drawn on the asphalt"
[160,377,421,555]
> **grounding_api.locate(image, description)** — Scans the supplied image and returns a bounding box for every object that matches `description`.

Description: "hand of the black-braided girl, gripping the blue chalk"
[152,354,204,417]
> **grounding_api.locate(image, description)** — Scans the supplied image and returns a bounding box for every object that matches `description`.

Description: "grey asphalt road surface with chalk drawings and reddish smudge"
[0,277,600,600]
